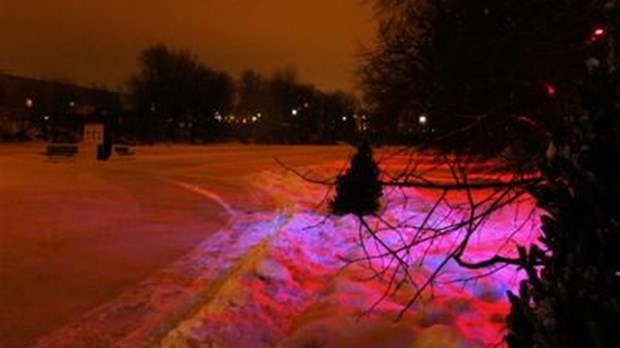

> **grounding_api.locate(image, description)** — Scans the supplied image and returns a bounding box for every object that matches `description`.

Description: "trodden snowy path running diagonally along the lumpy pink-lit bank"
[34,209,294,348]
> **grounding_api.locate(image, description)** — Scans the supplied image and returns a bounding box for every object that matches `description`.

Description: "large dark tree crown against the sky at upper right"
[361,0,605,162]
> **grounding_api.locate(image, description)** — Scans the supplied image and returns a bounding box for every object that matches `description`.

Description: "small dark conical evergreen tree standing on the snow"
[330,142,382,216]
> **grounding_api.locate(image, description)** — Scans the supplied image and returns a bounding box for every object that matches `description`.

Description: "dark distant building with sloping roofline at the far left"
[0,74,121,140]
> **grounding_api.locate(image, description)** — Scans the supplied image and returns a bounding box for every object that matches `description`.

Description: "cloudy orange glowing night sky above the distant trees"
[0,0,375,90]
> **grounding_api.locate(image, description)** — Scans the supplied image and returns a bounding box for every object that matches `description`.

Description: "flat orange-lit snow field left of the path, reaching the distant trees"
[0,144,348,347]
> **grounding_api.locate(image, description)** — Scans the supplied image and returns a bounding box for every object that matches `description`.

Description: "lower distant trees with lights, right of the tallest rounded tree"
[235,69,364,143]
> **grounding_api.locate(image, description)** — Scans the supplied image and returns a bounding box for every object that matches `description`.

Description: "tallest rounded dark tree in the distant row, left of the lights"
[130,45,233,140]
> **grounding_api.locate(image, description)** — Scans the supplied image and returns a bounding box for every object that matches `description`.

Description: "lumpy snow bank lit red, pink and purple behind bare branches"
[162,167,532,347]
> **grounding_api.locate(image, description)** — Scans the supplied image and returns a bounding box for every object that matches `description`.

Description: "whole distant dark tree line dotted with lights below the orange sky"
[118,44,368,143]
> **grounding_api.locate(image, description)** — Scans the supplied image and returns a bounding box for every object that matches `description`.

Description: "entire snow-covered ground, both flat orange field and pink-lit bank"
[0,144,534,347]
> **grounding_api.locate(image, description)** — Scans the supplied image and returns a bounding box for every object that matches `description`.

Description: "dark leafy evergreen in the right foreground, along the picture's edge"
[507,3,620,347]
